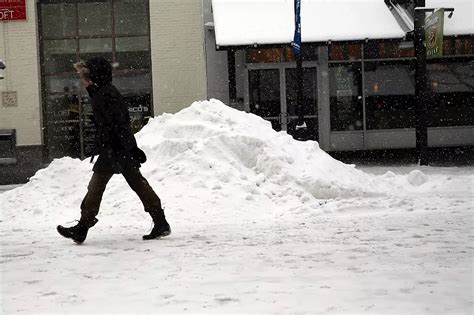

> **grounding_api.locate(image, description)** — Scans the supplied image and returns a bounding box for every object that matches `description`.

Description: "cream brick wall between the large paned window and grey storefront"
[150,0,207,115]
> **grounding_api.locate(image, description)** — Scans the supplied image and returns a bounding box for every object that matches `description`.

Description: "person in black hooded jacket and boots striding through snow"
[57,57,171,244]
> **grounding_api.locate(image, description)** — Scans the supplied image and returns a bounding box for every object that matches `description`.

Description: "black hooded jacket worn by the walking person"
[86,57,140,173]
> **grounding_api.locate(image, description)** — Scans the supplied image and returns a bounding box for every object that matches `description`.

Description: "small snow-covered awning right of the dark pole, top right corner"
[425,0,474,36]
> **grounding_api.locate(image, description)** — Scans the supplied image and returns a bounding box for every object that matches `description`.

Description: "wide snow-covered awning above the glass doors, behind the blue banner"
[212,0,405,46]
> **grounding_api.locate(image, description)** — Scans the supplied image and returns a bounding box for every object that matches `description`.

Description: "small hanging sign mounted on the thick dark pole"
[425,9,444,59]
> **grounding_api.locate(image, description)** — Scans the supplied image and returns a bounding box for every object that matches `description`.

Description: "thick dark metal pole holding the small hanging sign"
[414,0,428,165]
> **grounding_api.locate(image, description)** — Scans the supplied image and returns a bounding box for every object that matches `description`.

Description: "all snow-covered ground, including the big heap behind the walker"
[0,100,474,314]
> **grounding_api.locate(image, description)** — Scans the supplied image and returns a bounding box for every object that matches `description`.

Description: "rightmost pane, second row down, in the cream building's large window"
[115,36,151,69]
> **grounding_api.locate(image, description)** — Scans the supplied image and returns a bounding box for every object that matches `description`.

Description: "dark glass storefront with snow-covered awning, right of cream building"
[208,0,474,152]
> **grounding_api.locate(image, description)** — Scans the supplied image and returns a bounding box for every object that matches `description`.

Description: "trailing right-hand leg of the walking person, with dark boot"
[122,167,171,240]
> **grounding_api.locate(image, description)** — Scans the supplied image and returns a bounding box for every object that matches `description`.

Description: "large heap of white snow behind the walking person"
[0,100,408,226]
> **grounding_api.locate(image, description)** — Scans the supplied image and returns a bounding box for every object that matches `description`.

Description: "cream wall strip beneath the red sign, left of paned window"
[0,0,42,146]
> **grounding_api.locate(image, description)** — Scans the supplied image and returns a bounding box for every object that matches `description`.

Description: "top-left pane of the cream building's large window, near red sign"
[41,3,77,37]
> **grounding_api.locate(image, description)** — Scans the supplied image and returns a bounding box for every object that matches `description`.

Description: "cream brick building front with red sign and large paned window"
[0,0,207,184]
